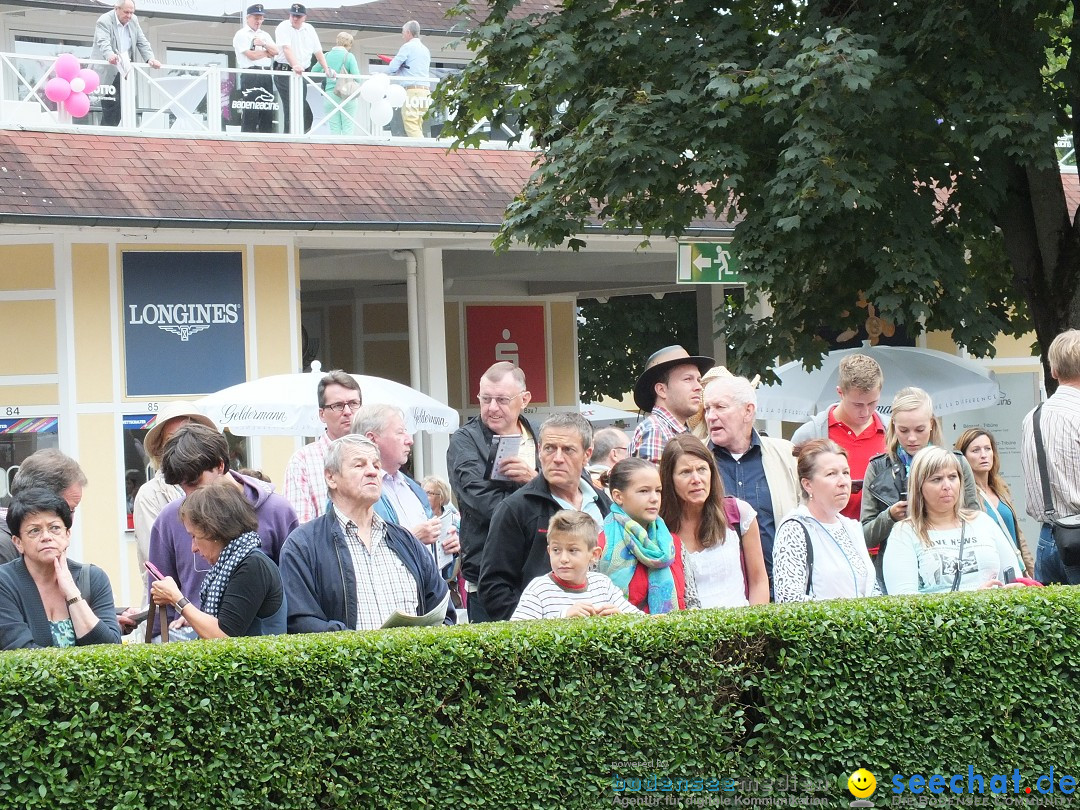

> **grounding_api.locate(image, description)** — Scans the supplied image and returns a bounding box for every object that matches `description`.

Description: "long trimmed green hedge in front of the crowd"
[0,588,1080,810]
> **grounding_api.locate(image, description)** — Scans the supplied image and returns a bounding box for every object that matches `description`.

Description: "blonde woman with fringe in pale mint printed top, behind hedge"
[882,447,1021,594]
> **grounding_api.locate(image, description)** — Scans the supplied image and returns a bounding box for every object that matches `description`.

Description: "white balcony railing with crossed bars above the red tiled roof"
[0,53,525,146]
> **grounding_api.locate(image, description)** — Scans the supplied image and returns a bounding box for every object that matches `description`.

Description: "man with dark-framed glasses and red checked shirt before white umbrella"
[285,368,363,523]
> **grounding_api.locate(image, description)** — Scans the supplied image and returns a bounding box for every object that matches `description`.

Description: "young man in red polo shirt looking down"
[792,354,888,521]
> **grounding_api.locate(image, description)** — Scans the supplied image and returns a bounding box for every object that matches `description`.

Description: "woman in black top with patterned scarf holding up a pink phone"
[150,480,287,638]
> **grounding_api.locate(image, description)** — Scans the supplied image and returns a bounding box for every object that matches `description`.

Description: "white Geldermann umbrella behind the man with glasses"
[197,361,459,436]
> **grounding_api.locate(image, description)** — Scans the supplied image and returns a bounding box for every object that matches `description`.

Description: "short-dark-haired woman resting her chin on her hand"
[0,488,120,650]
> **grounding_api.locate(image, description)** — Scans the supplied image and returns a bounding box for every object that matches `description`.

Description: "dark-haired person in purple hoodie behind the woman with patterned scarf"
[150,422,300,640]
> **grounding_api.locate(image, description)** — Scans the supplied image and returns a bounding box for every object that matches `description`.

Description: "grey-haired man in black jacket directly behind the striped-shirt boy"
[480,414,611,621]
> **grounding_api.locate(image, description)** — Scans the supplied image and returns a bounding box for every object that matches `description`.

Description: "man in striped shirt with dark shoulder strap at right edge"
[1023,329,1080,584]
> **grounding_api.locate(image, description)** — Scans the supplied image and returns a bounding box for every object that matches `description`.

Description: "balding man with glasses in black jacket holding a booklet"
[446,362,539,622]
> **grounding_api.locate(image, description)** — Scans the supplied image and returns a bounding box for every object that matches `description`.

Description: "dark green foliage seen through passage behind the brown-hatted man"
[578,293,698,402]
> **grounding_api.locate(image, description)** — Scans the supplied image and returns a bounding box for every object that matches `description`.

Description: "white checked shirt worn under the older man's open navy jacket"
[335,510,420,630]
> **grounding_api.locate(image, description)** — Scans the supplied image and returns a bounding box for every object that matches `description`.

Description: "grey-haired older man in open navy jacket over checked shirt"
[281,433,457,633]
